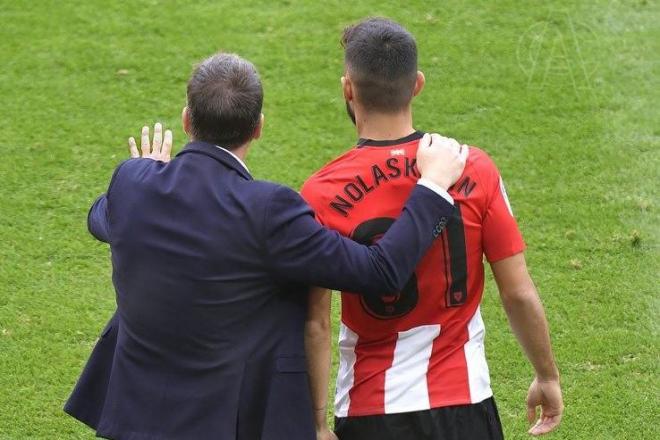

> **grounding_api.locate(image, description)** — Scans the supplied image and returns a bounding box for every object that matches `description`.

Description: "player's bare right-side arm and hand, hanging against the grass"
[491,253,564,436]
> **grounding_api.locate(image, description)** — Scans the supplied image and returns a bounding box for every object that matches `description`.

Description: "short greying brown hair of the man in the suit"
[187,53,264,148]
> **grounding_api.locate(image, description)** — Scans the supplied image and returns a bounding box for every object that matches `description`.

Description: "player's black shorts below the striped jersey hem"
[335,397,504,440]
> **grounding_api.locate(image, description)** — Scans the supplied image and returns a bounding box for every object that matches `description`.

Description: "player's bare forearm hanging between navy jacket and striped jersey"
[305,287,337,440]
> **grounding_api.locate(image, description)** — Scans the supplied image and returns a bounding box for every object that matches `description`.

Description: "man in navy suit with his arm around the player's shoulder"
[65,54,465,440]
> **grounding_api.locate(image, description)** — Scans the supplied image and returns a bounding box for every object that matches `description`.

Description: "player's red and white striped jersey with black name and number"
[301,132,525,417]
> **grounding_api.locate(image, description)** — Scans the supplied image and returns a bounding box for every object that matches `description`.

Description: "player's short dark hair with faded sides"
[341,18,417,113]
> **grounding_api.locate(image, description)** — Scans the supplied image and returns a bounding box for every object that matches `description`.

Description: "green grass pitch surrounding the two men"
[0,0,660,440]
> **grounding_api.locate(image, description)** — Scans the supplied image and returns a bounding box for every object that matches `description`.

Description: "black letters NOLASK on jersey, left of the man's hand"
[329,157,420,217]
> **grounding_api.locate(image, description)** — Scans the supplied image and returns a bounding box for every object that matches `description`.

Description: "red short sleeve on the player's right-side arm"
[482,170,525,263]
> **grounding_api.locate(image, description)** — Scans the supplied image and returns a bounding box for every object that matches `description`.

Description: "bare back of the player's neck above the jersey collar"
[355,110,415,140]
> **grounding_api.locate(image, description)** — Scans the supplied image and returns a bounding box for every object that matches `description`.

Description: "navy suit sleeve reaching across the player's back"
[264,185,453,296]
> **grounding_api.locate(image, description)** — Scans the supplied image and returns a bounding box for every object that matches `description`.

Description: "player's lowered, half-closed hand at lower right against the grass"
[527,378,564,436]
